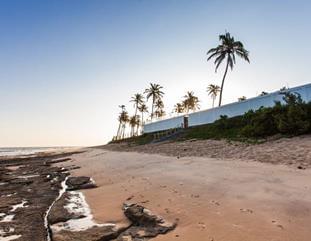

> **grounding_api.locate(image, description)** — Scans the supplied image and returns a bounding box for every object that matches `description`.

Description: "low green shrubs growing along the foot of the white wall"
[112,92,311,145]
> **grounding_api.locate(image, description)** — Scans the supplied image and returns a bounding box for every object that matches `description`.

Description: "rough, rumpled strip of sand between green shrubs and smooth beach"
[103,135,311,167]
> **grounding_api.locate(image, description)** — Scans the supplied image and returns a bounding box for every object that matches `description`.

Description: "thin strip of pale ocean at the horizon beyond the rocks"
[0,147,70,157]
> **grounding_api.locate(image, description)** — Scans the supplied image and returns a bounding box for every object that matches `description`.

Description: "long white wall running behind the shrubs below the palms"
[144,84,311,133]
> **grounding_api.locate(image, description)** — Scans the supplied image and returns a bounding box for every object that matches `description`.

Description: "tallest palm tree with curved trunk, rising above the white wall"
[207,33,249,106]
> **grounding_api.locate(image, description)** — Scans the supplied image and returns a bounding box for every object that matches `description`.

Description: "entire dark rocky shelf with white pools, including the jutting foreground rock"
[0,150,175,241]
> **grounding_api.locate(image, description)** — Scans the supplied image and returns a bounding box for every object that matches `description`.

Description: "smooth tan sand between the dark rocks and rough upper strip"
[59,137,311,241]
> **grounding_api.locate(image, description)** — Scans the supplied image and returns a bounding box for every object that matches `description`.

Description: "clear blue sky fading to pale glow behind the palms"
[0,0,311,147]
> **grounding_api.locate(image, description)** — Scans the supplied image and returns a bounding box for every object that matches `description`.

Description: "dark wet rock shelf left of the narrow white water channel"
[0,153,73,240]
